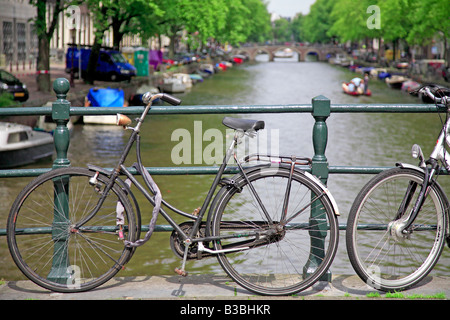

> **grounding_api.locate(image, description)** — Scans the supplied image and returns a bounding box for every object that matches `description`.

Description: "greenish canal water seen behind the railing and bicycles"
[0,55,450,280]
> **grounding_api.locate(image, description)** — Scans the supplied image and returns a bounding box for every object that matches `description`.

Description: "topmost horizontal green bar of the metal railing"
[0,104,446,116]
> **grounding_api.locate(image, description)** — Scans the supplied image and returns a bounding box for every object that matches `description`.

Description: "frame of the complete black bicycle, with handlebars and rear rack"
[74,94,339,276]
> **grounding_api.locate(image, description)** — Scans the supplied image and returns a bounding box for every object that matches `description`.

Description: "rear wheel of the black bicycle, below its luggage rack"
[208,167,339,295]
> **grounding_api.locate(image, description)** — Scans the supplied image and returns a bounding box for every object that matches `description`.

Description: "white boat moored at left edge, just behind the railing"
[0,122,54,169]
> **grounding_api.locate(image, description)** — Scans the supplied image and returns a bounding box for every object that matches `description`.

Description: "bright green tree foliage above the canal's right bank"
[324,0,450,44]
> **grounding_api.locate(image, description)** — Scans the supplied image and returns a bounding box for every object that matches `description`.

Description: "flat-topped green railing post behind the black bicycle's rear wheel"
[304,96,331,282]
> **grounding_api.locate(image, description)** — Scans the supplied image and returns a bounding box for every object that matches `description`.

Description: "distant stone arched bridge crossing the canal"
[233,45,344,61]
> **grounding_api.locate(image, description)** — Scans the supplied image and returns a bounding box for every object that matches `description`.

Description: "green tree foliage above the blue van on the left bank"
[87,0,271,50]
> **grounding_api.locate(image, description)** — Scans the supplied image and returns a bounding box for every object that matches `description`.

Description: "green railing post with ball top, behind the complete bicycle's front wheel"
[47,78,70,284]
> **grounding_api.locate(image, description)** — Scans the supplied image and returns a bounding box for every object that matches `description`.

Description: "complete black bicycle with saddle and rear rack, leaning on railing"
[7,93,339,295]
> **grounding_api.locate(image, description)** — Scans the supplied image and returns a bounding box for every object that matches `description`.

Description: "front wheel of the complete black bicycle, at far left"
[7,167,136,293]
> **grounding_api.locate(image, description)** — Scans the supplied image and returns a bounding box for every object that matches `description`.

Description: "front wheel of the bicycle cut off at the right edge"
[346,168,448,291]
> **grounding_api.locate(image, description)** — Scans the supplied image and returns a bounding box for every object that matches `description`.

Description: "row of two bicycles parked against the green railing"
[7,84,450,295]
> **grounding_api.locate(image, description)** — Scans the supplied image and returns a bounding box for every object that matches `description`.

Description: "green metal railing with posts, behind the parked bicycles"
[0,78,440,281]
